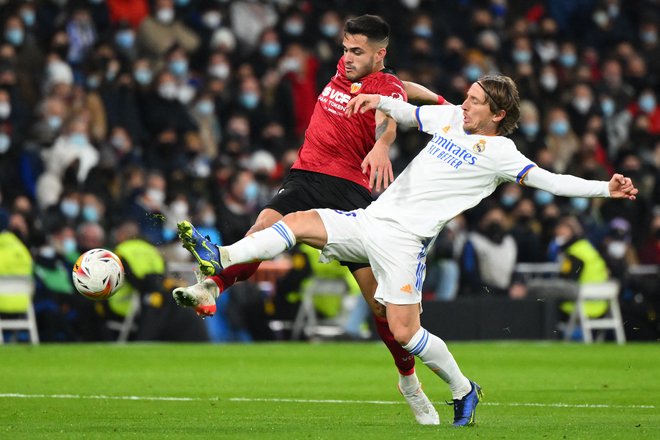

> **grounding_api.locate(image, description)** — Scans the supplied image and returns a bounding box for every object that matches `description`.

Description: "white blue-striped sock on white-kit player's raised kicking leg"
[220,221,296,267]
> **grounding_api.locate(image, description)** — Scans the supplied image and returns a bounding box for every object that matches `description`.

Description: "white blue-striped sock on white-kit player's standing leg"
[403,327,472,399]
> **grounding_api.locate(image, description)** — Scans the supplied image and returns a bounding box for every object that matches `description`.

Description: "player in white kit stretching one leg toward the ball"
[173,75,637,426]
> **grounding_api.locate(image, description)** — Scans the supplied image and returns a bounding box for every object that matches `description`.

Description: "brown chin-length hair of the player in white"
[477,75,520,136]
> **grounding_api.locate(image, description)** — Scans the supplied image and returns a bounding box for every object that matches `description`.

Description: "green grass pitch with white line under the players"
[0,343,660,440]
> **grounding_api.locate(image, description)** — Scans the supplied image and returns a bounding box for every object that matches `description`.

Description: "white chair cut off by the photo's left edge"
[0,275,39,344]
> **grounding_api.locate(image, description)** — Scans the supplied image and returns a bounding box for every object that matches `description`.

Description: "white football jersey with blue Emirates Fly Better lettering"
[366,105,535,238]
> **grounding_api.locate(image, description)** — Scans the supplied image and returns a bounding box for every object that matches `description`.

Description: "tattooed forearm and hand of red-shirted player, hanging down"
[362,111,396,191]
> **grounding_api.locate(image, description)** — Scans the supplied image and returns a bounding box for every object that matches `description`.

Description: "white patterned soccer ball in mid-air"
[72,249,124,301]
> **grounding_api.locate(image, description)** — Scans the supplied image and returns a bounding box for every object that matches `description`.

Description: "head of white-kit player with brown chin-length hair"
[461,75,520,136]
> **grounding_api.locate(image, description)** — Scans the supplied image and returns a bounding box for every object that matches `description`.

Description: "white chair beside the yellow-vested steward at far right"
[564,280,626,344]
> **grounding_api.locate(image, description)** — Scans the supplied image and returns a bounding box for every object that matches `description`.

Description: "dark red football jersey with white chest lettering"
[291,57,408,189]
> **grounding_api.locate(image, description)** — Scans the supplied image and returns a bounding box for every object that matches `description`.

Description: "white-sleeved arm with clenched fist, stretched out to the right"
[520,166,639,200]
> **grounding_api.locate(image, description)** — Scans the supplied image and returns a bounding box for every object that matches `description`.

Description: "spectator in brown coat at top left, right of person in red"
[137,0,199,64]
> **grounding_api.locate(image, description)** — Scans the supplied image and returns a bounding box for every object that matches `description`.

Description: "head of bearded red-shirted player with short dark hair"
[343,15,390,81]
